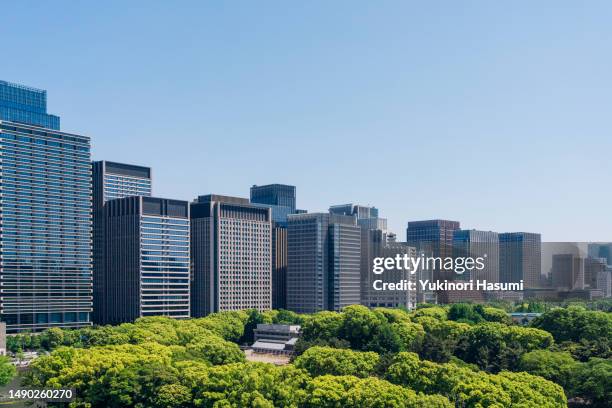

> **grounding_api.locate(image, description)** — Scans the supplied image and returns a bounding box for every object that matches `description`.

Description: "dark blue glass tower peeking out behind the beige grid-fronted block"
[251,184,298,309]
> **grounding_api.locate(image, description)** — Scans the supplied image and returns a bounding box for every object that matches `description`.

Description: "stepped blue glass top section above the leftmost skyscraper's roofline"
[0,81,60,130]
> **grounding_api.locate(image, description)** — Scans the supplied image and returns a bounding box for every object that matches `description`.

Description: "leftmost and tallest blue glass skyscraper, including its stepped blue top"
[0,82,92,333]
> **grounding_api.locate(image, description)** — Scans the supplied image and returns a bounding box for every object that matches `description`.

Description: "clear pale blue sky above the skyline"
[0,0,612,240]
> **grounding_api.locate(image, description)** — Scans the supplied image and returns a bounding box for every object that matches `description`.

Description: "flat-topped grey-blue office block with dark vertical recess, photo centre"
[287,213,361,313]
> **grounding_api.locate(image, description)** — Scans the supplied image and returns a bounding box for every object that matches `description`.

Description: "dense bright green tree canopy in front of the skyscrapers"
[3,302,612,408]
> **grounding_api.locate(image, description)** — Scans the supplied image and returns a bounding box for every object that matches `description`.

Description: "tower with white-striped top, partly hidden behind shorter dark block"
[92,160,151,324]
